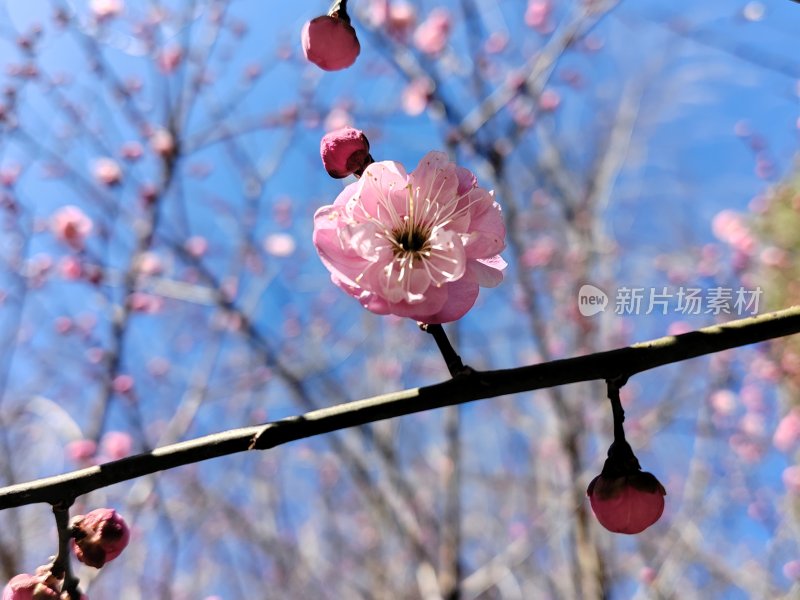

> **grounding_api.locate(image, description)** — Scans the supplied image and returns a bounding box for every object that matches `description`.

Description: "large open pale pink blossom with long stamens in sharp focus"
[314,152,506,324]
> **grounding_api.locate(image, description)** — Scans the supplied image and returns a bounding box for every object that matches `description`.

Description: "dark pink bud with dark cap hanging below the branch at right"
[586,441,667,534]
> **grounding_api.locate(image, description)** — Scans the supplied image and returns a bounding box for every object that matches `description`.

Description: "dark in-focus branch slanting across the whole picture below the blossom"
[0,306,800,510]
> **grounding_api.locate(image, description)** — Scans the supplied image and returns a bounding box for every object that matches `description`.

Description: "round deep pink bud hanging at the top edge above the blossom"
[301,15,361,71]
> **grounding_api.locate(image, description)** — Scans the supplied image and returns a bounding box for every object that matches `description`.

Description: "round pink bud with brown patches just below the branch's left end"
[72,508,130,569]
